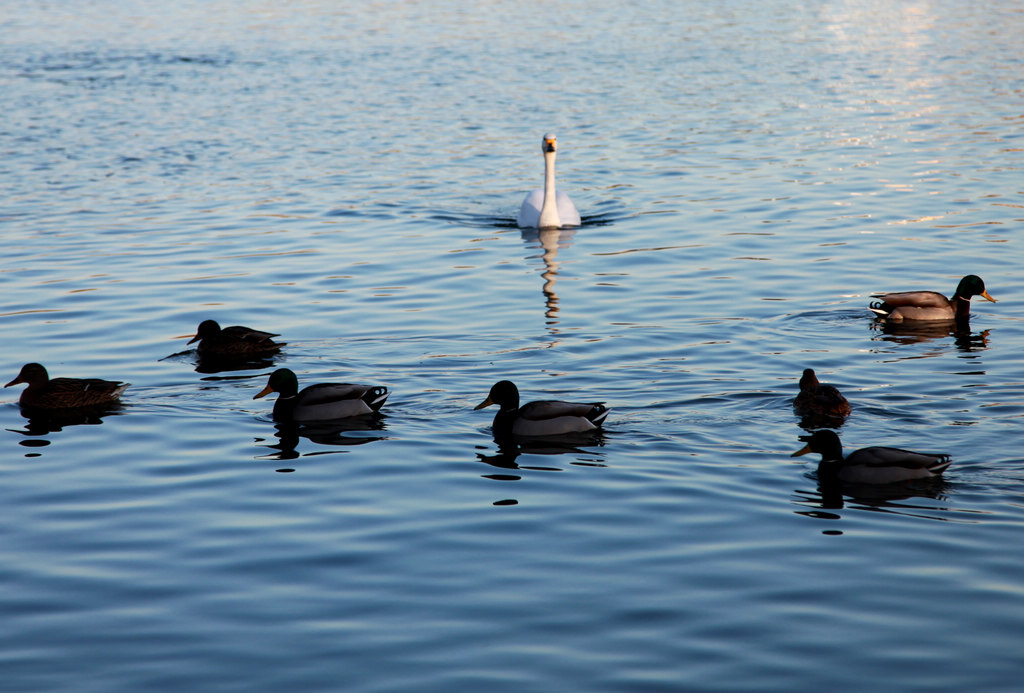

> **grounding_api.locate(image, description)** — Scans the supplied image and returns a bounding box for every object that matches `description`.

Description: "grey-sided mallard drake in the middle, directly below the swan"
[473,380,610,436]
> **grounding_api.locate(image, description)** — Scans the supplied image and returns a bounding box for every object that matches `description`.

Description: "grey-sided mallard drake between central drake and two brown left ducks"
[253,369,390,423]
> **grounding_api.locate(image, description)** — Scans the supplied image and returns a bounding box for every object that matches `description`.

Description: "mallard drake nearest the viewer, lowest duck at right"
[791,430,952,483]
